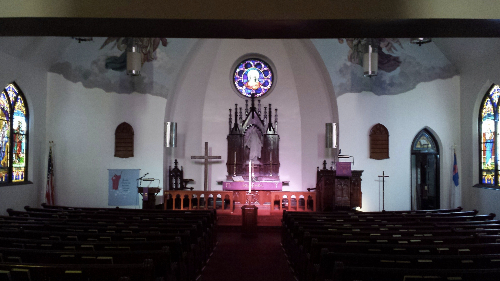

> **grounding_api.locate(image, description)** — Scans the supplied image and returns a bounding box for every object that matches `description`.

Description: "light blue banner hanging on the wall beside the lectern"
[108,169,140,206]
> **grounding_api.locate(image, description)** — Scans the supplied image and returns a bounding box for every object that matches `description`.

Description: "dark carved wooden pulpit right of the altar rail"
[316,161,363,212]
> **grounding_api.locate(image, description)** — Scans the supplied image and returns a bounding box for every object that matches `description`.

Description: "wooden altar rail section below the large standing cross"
[163,190,234,212]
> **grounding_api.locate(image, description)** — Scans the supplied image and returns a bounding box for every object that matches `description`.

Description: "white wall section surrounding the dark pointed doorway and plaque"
[337,77,460,211]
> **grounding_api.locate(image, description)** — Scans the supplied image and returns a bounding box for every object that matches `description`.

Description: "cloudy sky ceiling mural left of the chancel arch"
[50,37,196,98]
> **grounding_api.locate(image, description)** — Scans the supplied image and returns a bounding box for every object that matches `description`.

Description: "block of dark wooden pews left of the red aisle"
[0,204,217,281]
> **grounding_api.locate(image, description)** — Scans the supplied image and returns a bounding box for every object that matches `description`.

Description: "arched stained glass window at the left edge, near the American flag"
[0,83,29,184]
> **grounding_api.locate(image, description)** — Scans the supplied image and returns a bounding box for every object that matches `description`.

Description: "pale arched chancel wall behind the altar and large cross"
[168,39,338,191]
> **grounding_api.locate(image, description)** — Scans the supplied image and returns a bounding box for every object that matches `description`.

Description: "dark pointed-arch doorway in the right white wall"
[411,129,440,210]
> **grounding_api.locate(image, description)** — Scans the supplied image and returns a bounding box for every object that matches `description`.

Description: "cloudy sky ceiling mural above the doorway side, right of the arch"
[312,38,458,97]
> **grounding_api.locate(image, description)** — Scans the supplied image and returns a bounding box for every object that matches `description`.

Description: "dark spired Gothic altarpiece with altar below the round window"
[223,97,282,191]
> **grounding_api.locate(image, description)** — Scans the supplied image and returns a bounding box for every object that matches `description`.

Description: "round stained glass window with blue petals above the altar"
[233,59,274,98]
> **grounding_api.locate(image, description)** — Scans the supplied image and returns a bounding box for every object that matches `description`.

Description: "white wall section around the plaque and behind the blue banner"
[47,73,166,208]
